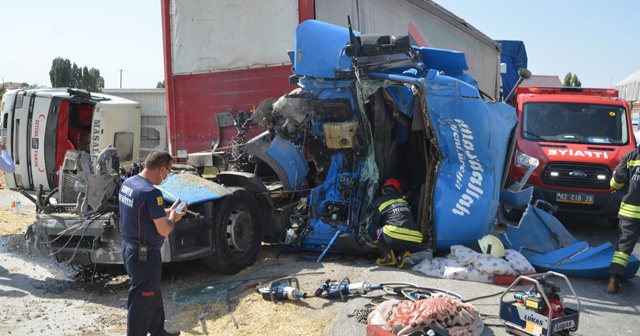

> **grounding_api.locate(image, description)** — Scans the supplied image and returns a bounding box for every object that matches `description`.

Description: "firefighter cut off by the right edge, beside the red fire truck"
[607,148,640,293]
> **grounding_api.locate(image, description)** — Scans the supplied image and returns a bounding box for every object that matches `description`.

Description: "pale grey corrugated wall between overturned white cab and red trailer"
[102,89,167,161]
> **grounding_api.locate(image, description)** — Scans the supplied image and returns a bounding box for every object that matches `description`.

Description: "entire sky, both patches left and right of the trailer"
[0,0,640,88]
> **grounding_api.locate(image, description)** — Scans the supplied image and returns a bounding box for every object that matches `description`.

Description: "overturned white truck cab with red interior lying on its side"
[2,88,140,191]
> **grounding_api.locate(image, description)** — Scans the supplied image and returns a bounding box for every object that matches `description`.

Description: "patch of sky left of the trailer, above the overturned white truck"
[0,0,164,88]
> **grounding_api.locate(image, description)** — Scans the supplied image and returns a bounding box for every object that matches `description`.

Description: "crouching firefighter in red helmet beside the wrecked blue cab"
[368,178,424,268]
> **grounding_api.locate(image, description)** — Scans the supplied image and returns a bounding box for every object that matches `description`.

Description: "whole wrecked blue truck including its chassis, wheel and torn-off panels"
[17,20,640,277]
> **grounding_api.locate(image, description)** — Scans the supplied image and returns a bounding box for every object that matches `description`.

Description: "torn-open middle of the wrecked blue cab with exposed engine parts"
[245,59,426,253]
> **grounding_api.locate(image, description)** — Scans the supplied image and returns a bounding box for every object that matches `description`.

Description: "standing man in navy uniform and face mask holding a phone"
[118,151,186,336]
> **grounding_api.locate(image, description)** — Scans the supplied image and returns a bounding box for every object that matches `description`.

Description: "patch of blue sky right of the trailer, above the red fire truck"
[435,0,640,88]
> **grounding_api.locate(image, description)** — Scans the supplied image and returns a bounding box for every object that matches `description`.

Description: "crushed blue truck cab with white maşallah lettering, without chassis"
[245,21,640,277]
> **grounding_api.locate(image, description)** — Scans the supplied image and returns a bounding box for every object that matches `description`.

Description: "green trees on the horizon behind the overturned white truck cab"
[49,57,104,92]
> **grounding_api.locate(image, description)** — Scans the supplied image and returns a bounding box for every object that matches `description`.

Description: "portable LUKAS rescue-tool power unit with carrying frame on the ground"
[500,272,580,336]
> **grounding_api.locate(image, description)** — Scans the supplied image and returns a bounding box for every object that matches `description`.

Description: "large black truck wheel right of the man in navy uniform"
[204,189,262,274]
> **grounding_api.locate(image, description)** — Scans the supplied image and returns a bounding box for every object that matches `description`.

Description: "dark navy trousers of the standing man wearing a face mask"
[122,242,165,336]
